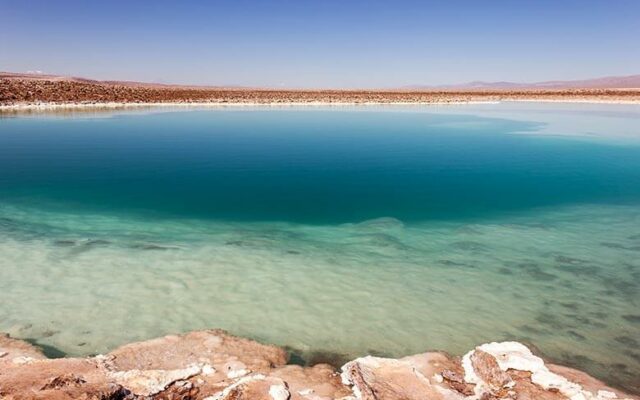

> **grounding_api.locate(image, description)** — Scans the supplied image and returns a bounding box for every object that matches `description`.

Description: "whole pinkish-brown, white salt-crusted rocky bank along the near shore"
[0,330,636,400]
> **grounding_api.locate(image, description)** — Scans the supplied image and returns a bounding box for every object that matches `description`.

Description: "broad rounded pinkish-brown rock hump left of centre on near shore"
[108,330,287,396]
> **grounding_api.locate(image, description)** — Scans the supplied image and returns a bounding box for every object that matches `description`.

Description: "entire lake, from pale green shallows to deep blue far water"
[0,103,640,391]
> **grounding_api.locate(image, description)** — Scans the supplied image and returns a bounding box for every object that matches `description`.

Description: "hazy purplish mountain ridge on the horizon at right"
[406,75,640,89]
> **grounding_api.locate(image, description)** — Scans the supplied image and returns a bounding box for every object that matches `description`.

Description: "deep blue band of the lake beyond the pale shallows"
[0,110,640,224]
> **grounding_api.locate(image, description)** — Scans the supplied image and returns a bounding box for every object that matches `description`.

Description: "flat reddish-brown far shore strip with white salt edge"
[0,74,640,110]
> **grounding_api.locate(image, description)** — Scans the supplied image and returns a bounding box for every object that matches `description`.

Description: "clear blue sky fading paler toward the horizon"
[0,0,640,87]
